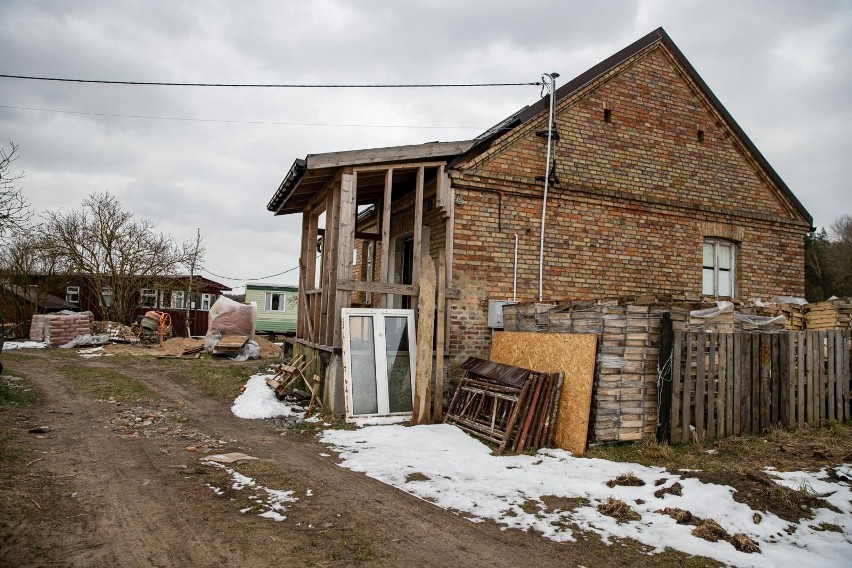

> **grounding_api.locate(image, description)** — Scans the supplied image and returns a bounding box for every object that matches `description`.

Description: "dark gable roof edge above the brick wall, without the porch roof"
[460,27,815,231]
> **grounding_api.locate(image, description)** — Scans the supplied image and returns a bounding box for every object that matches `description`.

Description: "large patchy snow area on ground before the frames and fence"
[321,424,852,568]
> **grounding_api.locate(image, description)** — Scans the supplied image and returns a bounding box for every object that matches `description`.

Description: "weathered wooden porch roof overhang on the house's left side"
[266,140,474,215]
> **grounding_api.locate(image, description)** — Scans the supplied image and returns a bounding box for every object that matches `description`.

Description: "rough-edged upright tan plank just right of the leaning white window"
[411,255,436,424]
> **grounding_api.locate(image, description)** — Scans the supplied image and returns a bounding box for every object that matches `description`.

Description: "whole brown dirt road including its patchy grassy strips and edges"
[0,351,716,568]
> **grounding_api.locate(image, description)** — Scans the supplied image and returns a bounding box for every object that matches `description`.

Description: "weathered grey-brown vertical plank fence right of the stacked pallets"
[661,330,852,443]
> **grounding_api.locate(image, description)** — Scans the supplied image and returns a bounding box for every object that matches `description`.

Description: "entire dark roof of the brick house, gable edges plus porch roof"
[266,27,816,226]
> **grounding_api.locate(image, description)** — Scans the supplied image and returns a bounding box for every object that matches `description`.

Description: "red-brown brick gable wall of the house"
[450,42,809,355]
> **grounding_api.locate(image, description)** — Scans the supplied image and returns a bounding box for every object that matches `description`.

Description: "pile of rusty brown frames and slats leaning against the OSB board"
[444,357,562,454]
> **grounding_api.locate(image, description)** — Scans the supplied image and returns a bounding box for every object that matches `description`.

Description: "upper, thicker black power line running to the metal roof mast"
[0,74,541,89]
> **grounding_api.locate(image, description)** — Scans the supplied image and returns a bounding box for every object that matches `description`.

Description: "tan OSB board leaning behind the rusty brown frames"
[491,331,597,456]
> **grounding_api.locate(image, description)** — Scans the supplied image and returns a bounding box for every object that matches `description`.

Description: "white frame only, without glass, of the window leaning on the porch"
[341,308,417,422]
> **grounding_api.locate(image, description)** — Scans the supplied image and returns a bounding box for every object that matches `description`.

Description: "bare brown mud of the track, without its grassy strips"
[5,353,712,568]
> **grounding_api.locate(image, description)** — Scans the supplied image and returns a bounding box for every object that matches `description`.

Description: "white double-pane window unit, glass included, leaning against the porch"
[342,308,416,422]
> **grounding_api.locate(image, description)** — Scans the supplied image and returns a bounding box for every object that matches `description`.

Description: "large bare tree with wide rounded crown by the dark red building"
[45,192,181,322]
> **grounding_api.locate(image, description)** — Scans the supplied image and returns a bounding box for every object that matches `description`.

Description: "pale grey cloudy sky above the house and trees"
[0,0,852,287]
